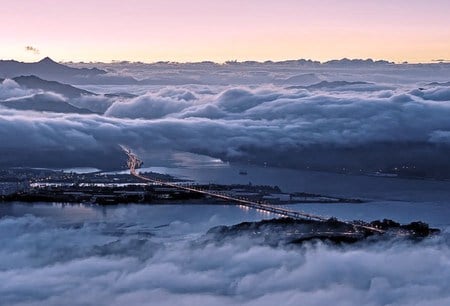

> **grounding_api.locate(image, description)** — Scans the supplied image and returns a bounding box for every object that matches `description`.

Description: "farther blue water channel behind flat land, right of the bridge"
[122,164,450,203]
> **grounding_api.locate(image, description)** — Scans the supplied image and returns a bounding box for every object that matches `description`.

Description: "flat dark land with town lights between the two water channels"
[0,168,362,205]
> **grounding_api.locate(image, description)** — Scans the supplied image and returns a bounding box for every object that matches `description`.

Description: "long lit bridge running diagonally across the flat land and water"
[121,145,384,233]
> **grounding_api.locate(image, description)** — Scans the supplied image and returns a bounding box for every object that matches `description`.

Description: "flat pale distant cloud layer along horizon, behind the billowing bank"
[66,60,450,86]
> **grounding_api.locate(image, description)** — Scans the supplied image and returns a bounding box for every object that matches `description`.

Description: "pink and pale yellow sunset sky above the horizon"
[0,0,450,62]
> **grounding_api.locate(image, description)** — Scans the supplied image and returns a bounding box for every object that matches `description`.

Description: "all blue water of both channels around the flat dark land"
[5,153,450,230]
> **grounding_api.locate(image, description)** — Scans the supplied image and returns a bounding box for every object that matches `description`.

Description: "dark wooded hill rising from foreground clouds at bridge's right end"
[204,218,440,246]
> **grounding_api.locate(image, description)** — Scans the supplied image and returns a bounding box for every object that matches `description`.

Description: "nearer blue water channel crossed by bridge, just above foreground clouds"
[0,202,450,231]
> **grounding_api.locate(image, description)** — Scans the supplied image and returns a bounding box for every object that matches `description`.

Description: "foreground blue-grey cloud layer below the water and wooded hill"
[0,207,450,306]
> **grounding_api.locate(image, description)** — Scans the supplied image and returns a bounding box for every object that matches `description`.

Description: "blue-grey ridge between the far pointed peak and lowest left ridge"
[13,75,96,98]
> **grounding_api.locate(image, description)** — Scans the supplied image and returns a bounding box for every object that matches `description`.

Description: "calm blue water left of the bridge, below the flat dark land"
[0,202,266,232]
